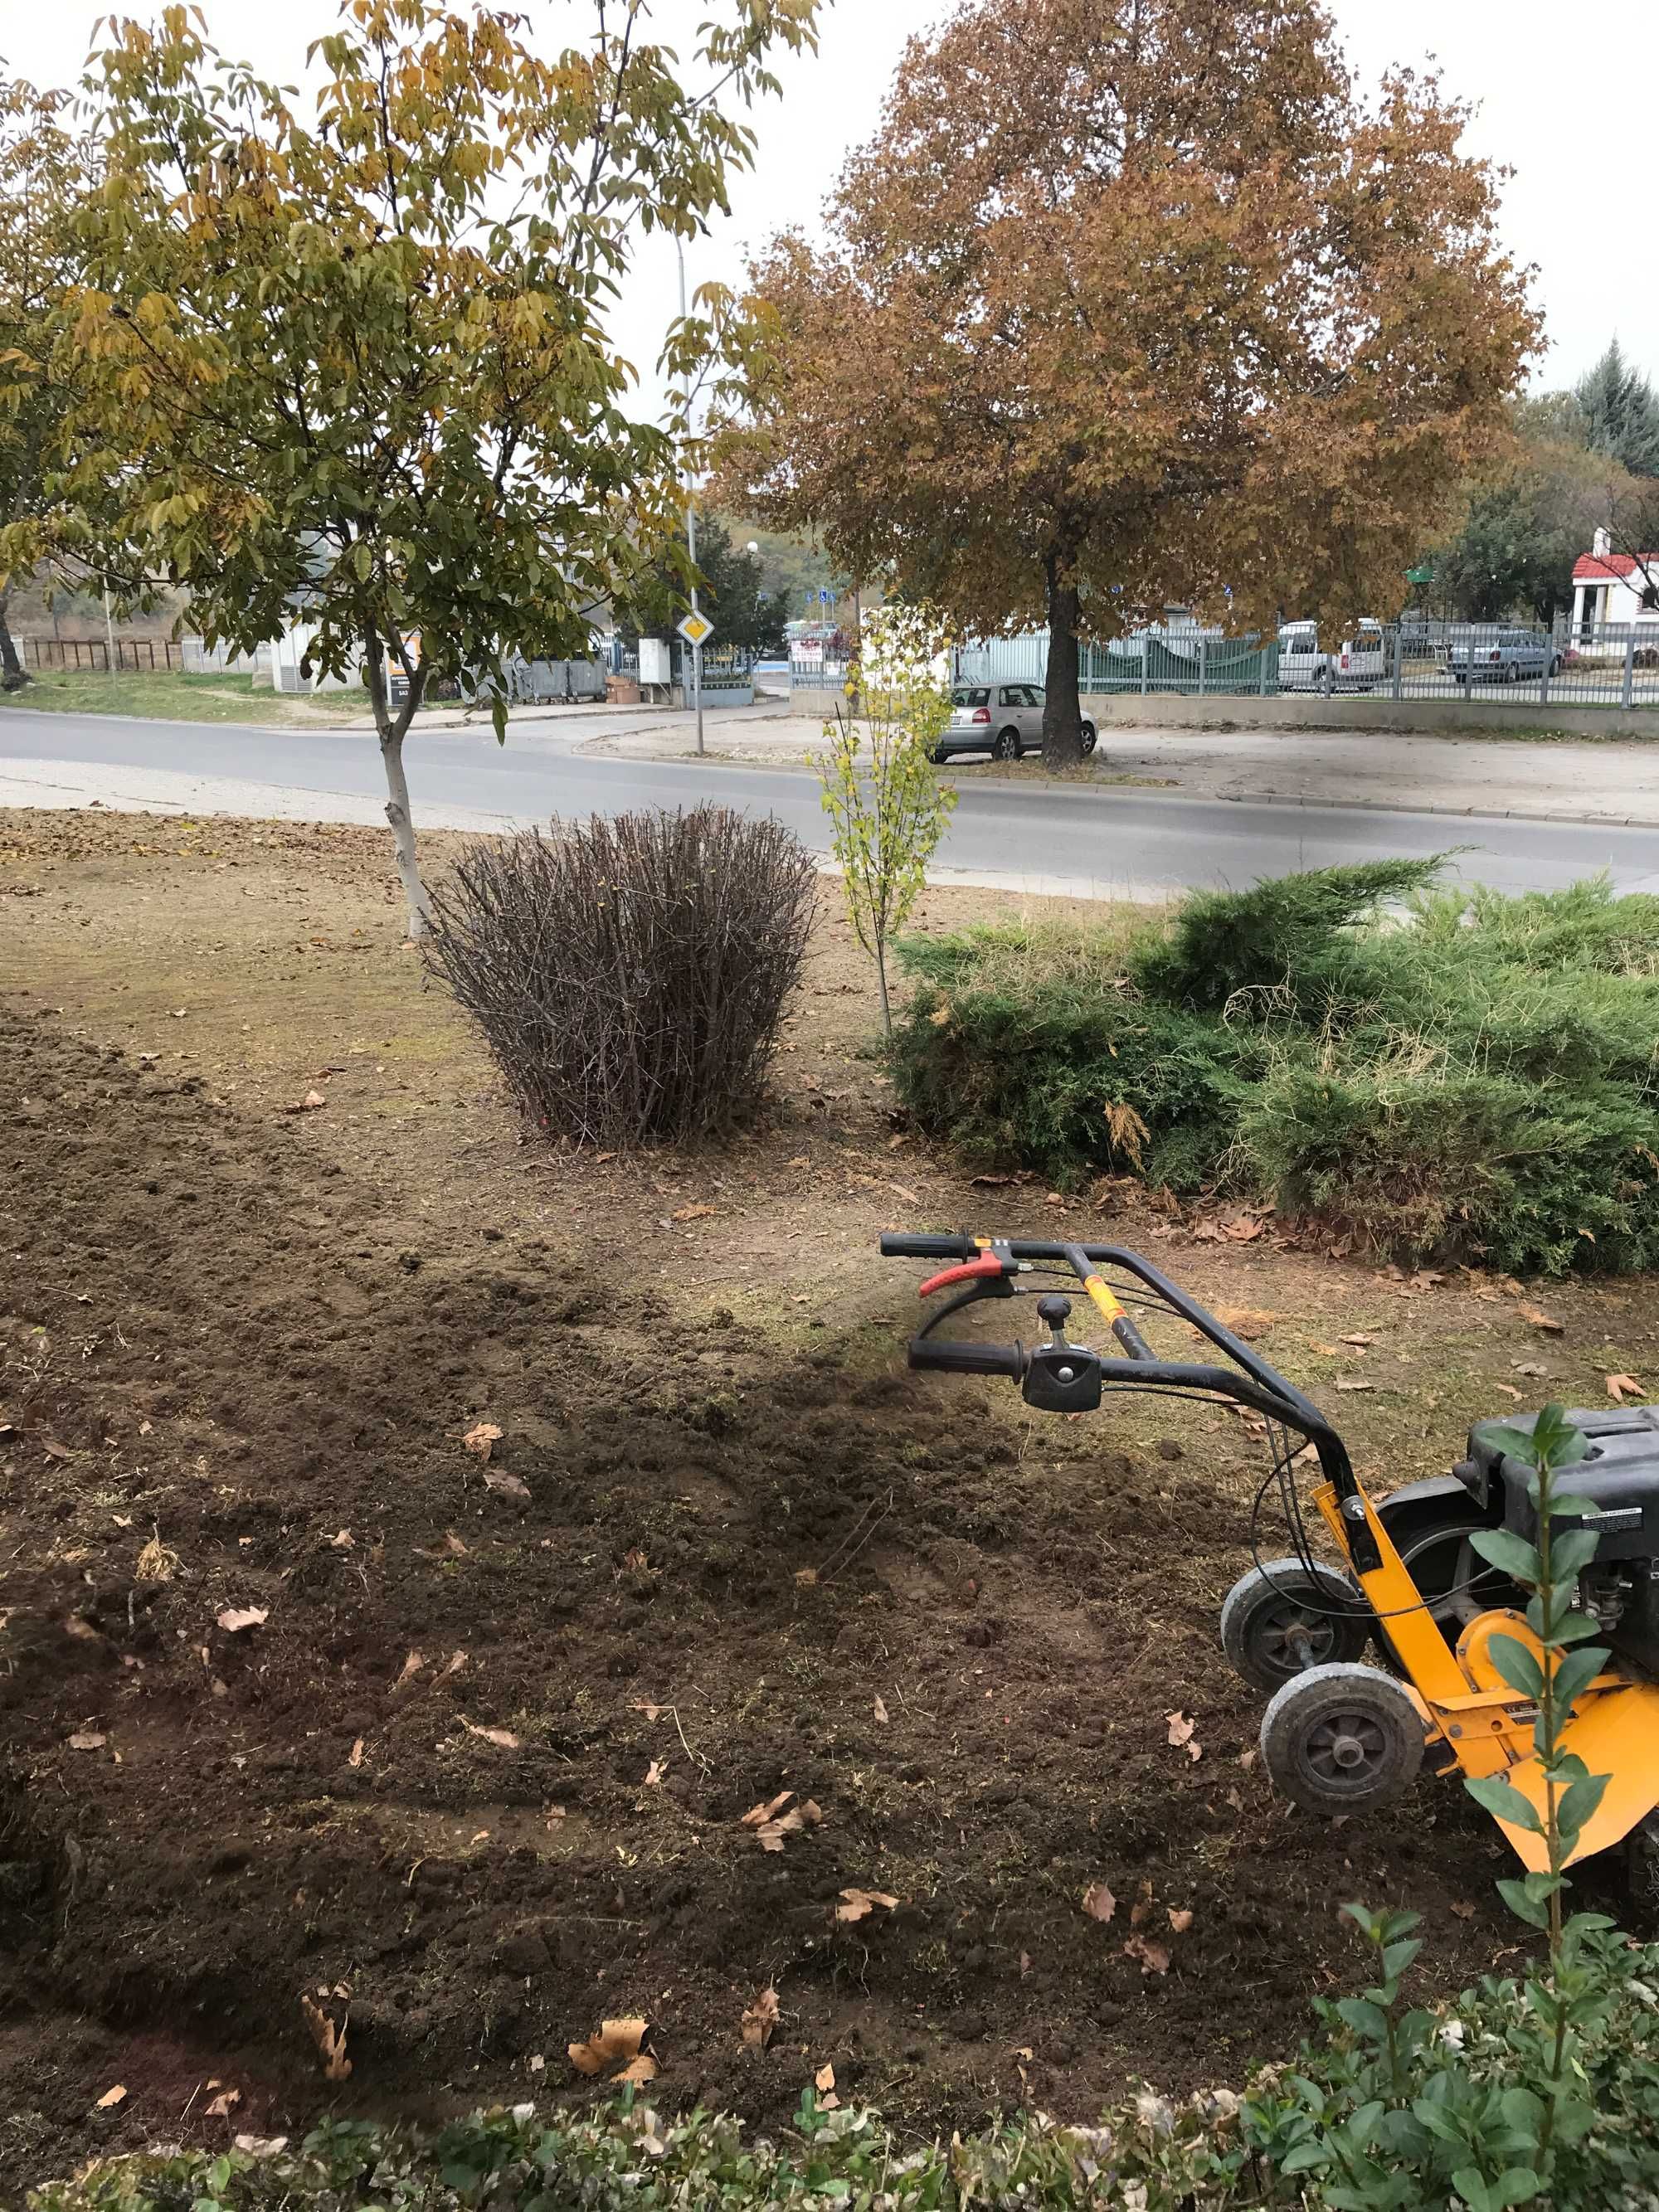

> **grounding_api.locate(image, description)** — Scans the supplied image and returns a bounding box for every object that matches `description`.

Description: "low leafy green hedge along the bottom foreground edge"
[29,1918,1659,2212]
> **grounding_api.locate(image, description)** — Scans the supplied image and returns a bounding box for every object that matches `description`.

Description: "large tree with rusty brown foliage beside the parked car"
[726,0,1537,766]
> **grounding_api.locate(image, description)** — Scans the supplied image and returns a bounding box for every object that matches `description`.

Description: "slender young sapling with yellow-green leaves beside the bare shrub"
[819,606,956,1039]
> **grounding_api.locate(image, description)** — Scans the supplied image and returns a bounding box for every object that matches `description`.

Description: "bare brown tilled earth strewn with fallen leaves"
[0,814,1657,2199]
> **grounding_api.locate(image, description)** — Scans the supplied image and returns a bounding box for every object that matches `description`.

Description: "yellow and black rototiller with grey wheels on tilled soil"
[880,1237,1659,1909]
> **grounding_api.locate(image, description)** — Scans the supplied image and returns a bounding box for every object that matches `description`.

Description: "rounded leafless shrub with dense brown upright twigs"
[427,805,816,1146]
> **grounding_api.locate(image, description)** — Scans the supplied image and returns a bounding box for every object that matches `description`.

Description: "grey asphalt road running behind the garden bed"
[0,707,1659,896]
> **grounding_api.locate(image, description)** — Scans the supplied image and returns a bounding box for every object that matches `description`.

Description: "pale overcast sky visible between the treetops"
[0,0,1659,406]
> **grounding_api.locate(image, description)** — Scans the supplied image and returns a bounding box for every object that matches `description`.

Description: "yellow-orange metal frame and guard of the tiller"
[1314,1482,1659,1871]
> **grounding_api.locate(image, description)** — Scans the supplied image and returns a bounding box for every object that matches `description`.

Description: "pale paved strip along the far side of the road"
[581,706,1659,827]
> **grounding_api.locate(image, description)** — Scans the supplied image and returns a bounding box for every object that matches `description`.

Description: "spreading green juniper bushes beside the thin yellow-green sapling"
[893,860,1659,1274]
